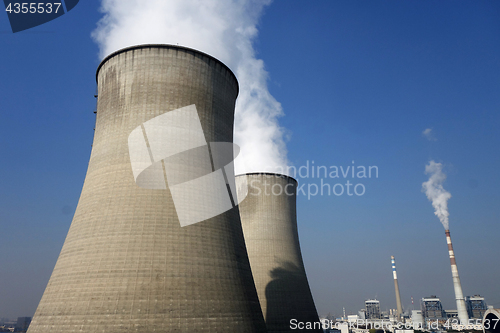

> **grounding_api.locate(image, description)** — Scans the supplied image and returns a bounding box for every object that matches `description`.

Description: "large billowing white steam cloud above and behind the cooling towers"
[92,0,288,174]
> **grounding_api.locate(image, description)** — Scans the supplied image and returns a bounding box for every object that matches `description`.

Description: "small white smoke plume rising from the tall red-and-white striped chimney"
[422,161,451,230]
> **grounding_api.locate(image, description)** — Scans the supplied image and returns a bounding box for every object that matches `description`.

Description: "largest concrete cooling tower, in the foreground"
[29,45,266,333]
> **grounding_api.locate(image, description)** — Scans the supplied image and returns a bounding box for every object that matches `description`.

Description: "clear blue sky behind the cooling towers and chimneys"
[0,0,500,317]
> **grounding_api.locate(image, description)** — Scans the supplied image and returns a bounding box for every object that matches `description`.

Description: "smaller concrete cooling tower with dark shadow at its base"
[236,173,322,333]
